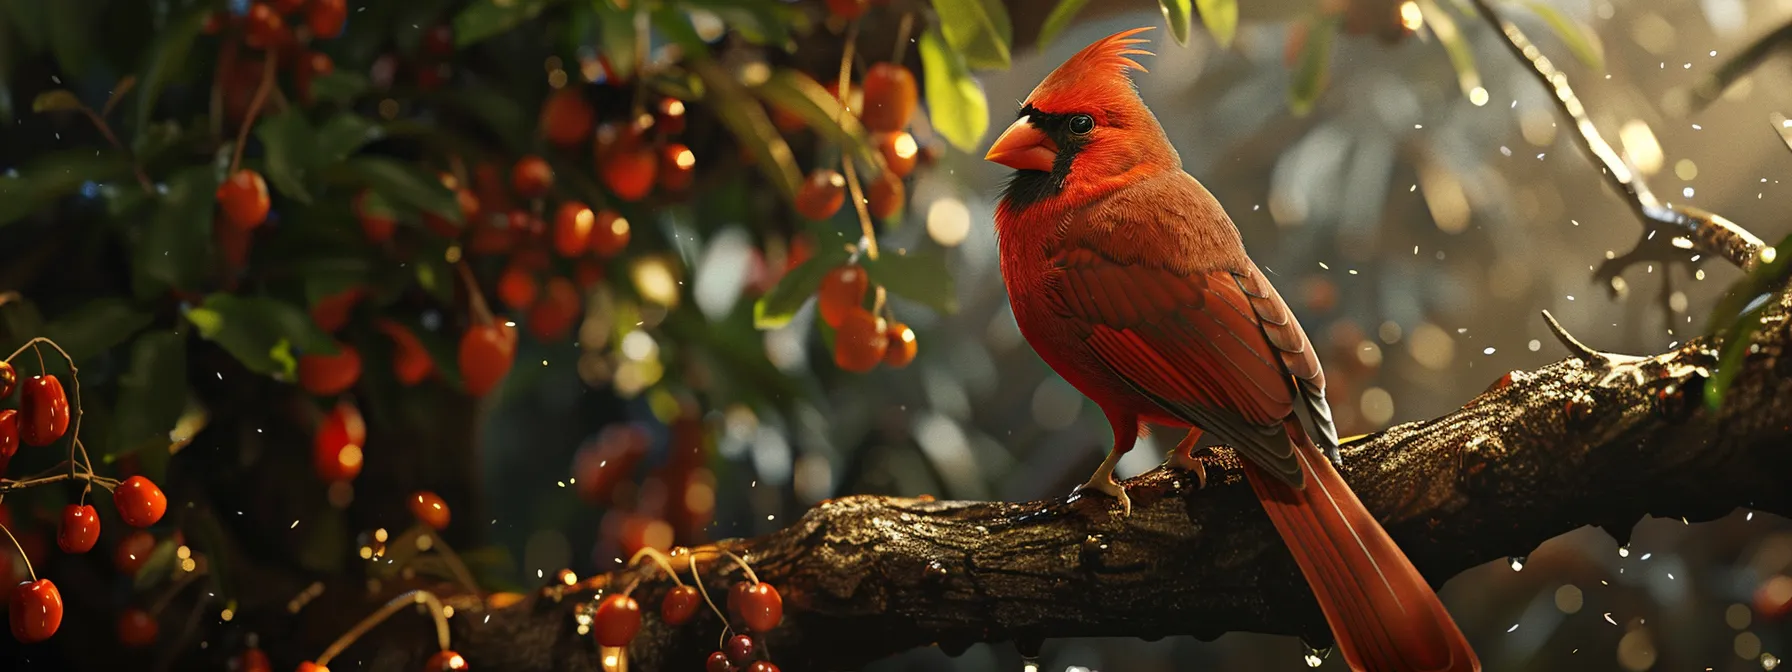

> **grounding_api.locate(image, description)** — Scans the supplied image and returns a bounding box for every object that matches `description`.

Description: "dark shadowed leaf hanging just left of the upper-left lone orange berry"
[133,165,219,289]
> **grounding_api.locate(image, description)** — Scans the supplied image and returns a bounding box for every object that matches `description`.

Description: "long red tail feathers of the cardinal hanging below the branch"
[1245,423,1480,672]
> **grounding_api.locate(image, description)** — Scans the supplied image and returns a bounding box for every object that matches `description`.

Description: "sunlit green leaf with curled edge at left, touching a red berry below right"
[186,292,337,378]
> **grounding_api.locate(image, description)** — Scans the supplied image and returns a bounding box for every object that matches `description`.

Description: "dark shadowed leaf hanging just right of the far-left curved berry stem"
[109,330,188,480]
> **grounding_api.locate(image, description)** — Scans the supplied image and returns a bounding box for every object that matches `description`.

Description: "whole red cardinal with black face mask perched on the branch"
[986,29,1480,672]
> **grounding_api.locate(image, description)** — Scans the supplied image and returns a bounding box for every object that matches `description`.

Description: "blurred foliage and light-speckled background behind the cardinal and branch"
[0,0,1792,670]
